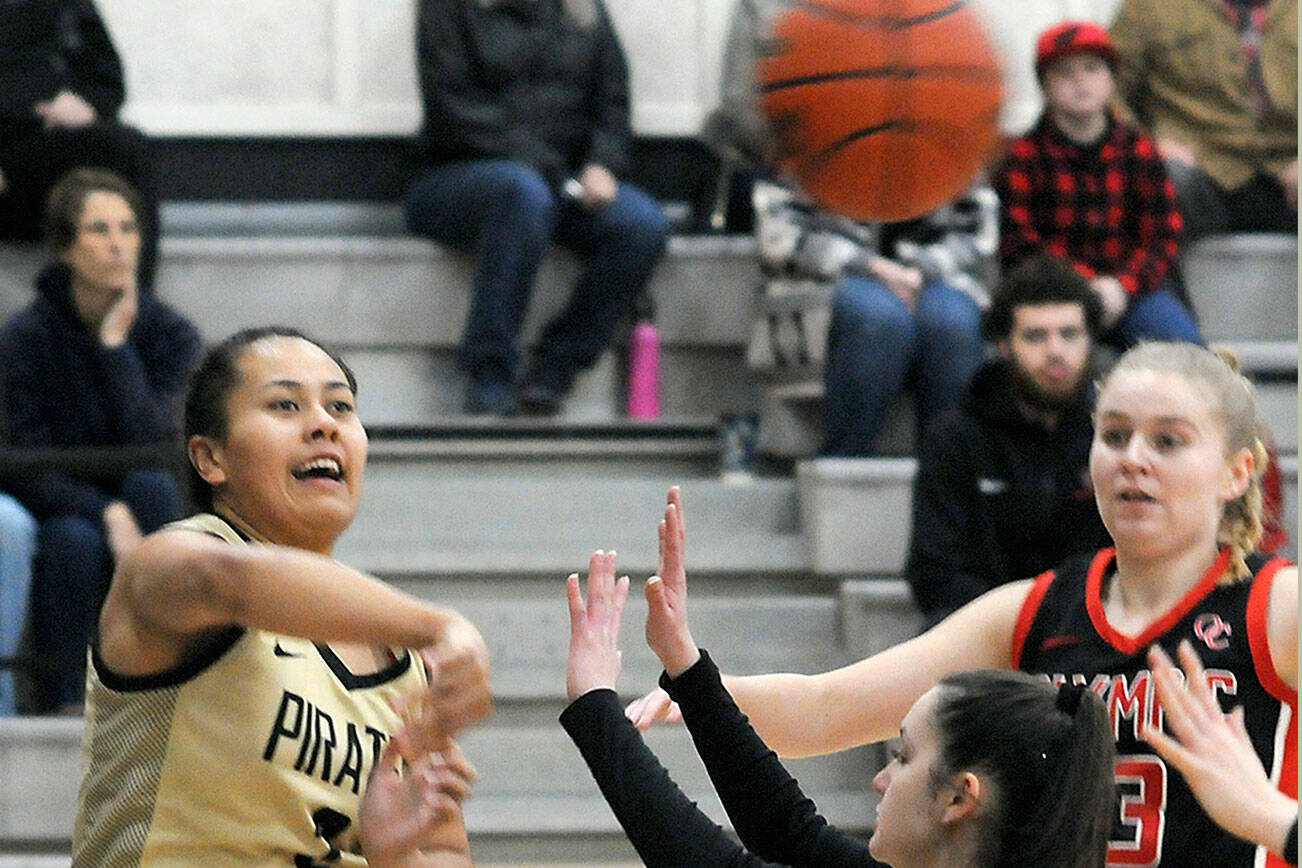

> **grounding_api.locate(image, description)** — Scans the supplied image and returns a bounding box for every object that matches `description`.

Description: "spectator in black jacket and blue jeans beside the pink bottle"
[406,0,668,415]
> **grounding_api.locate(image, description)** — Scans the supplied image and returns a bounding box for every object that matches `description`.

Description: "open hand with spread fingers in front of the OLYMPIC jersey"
[1139,640,1298,852]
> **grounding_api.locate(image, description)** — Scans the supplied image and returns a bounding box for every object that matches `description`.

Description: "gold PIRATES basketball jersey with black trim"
[73,515,426,868]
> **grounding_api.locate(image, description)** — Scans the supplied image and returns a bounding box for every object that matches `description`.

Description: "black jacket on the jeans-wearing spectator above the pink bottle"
[417,0,631,185]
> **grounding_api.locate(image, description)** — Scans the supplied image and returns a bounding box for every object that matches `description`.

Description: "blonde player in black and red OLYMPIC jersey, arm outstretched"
[629,344,1298,868]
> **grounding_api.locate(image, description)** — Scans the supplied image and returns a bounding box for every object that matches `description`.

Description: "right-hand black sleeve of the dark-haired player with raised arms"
[660,651,881,868]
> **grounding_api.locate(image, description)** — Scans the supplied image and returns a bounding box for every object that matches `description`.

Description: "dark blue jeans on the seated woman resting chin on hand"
[31,470,181,711]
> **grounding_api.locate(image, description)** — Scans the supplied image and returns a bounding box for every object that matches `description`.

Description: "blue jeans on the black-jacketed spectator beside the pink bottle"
[406,159,669,387]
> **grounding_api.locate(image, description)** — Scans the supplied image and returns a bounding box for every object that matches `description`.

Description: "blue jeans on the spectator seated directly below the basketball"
[823,276,984,455]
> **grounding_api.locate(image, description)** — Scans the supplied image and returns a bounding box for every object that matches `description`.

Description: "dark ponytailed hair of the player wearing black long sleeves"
[932,670,1116,868]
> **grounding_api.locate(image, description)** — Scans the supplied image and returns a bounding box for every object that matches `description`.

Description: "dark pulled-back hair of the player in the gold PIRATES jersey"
[182,325,357,510]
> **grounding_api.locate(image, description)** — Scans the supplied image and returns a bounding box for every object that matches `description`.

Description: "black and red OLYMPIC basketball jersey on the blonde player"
[1013,548,1298,868]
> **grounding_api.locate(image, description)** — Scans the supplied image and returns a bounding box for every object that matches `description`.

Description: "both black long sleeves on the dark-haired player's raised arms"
[561,651,881,868]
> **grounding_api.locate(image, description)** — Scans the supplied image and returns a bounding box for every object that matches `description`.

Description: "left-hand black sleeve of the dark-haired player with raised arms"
[561,690,769,868]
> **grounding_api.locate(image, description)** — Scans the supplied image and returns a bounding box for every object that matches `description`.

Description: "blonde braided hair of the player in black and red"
[1099,341,1267,582]
